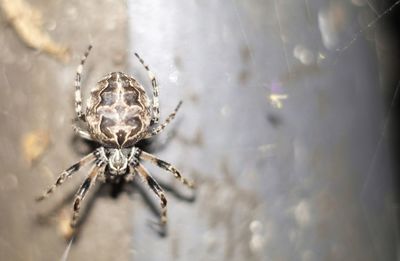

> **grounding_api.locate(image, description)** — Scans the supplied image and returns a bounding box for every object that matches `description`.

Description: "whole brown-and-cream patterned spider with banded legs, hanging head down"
[37,45,194,227]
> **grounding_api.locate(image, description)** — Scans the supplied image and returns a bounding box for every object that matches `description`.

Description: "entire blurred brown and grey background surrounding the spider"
[0,0,400,261]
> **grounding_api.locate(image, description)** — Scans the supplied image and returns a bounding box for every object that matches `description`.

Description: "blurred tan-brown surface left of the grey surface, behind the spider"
[0,0,131,261]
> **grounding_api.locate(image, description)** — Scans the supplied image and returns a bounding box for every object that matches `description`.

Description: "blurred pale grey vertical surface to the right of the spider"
[129,0,397,260]
